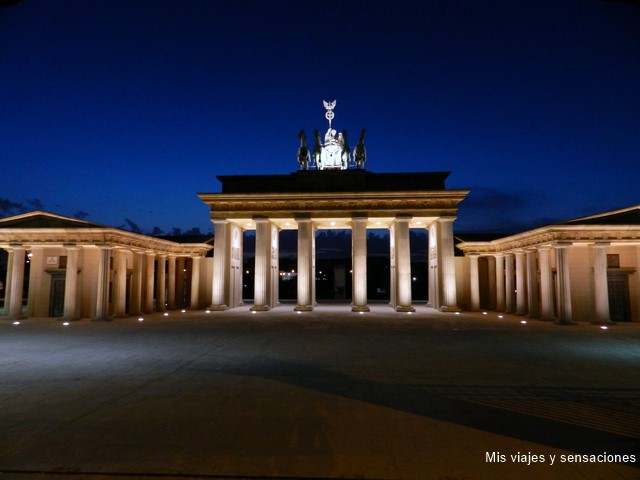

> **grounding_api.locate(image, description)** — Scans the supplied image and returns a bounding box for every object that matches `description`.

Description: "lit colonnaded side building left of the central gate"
[0,211,212,321]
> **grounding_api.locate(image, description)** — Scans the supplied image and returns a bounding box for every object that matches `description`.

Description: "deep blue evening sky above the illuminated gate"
[0,0,640,231]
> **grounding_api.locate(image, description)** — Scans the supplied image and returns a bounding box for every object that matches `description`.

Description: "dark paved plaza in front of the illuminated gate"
[0,304,640,480]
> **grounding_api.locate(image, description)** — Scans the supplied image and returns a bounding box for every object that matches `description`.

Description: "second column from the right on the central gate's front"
[390,216,416,312]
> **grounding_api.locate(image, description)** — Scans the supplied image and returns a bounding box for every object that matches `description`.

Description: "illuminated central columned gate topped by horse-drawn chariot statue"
[198,101,469,312]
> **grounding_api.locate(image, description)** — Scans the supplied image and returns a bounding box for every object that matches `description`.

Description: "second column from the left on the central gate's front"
[251,218,275,311]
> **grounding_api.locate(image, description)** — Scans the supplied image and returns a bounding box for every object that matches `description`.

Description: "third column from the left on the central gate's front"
[295,218,316,312]
